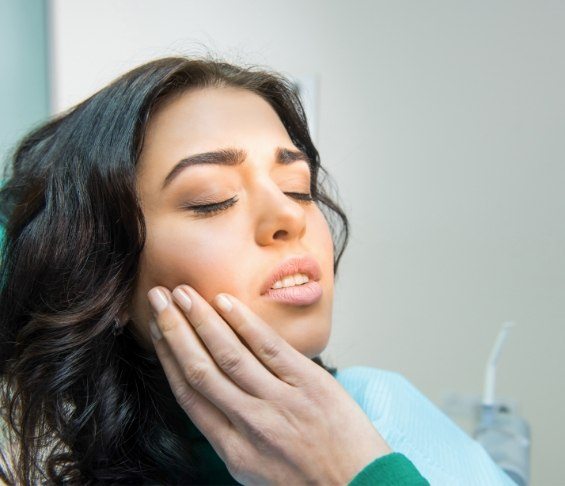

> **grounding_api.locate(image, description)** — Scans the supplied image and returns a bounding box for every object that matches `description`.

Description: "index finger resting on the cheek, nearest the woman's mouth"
[209,294,312,386]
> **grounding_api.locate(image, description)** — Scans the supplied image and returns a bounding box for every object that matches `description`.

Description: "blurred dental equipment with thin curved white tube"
[473,322,530,486]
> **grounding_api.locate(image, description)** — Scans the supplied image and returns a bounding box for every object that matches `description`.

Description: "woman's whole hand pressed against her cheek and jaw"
[149,285,392,485]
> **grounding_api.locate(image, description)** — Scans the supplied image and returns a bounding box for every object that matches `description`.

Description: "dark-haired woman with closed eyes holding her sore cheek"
[0,58,512,484]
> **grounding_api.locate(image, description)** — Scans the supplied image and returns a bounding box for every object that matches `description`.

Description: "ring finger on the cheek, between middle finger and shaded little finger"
[149,287,253,423]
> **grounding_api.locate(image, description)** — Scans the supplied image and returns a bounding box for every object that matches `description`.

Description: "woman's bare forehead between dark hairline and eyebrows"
[136,88,300,199]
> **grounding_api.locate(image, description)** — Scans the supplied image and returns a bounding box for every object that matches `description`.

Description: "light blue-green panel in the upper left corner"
[0,0,49,166]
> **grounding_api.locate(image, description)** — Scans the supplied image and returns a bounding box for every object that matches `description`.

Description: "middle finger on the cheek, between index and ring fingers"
[173,285,283,398]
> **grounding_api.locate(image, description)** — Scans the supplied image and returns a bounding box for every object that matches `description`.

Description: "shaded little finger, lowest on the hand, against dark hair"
[153,328,233,454]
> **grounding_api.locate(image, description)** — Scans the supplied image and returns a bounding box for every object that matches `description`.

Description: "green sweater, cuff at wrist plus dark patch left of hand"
[185,423,429,486]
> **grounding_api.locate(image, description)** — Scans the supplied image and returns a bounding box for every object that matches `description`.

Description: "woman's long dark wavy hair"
[0,57,348,484]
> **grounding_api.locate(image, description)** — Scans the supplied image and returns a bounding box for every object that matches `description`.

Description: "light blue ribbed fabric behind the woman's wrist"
[336,366,515,486]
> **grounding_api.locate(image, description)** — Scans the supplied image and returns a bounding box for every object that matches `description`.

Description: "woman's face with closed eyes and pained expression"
[130,88,333,357]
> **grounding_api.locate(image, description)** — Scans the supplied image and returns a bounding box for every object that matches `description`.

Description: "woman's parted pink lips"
[261,256,322,305]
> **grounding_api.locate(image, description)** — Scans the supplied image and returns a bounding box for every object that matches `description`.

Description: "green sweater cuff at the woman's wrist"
[348,452,430,486]
